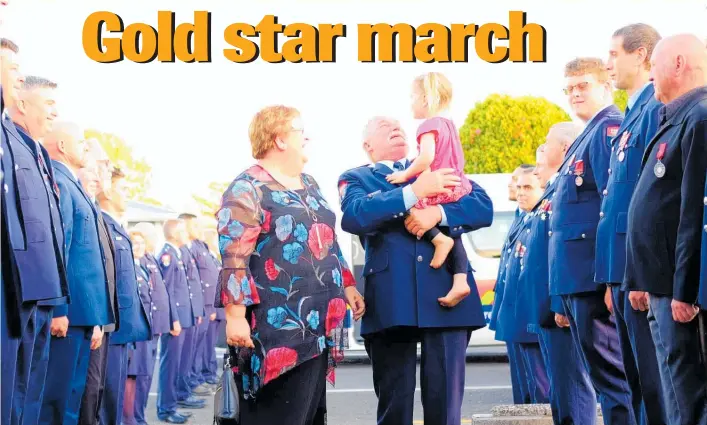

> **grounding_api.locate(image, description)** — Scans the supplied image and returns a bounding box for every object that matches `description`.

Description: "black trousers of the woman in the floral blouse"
[236,351,327,425]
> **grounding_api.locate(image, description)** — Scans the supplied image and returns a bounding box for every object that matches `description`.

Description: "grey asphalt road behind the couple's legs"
[141,359,513,425]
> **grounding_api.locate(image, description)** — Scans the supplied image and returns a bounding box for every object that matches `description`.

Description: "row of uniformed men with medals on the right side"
[490,24,707,425]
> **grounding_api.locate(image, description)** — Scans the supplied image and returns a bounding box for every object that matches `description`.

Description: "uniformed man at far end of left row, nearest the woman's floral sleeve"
[179,213,218,395]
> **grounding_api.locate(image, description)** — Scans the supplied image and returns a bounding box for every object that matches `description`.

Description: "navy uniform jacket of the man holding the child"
[338,164,493,335]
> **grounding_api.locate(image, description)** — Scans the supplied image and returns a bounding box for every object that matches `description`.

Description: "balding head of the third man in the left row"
[42,121,87,172]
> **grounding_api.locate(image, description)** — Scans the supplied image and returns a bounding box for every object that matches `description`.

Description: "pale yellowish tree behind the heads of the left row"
[84,129,162,206]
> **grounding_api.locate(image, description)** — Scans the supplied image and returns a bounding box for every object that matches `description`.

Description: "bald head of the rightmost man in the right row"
[651,34,707,103]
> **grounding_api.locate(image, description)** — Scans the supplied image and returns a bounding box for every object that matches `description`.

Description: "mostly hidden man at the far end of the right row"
[489,164,533,404]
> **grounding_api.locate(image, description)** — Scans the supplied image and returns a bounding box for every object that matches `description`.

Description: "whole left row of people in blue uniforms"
[0,39,222,425]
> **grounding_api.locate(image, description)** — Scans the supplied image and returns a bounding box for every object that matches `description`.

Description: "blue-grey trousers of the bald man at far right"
[648,294,707,425]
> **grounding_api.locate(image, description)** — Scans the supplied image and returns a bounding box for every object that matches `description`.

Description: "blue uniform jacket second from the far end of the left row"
[159,243,194,329]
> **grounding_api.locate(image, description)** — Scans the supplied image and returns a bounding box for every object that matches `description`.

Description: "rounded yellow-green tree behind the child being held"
[459,94,570,174]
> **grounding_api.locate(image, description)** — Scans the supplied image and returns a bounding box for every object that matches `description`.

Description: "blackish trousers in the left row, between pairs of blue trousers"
[79,333,110,425]
